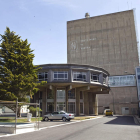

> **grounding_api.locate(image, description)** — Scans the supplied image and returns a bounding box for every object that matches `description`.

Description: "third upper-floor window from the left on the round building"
[73,72,86,81]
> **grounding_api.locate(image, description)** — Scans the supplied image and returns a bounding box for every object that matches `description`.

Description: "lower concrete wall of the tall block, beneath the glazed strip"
[97,87,138,114]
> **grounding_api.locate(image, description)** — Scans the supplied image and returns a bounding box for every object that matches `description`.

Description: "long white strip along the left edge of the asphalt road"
[0,117,102,137]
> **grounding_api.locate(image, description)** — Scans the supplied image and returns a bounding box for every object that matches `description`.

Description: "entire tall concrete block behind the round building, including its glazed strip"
[67,10,139,114]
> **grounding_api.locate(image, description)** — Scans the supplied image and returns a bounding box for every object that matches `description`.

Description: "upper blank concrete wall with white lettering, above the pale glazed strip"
[67,10,139,75]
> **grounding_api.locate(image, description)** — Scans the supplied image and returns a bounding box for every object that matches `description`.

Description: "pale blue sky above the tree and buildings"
[0,0,140,65]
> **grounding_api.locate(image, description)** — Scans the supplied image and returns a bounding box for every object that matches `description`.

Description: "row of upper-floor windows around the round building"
[38,71,105,83]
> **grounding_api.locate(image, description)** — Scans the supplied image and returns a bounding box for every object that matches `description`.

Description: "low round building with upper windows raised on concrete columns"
[31,64,109,115]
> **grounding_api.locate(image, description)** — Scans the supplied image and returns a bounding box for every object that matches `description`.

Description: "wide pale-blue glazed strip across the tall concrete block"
[109,75,136,87]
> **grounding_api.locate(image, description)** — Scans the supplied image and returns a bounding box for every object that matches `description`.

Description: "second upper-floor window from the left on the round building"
[53,71,68,80]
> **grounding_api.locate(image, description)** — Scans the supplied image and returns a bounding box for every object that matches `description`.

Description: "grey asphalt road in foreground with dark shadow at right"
[0,116,140,140]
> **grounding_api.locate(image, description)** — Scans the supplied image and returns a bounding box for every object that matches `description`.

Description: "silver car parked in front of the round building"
[43,111,74,121]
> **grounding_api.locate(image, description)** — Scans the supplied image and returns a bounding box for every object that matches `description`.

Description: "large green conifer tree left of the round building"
[0,27,43,116]
